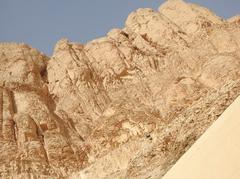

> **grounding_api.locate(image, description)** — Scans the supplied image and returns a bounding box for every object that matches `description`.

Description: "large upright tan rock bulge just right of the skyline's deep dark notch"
[47,40,109,119]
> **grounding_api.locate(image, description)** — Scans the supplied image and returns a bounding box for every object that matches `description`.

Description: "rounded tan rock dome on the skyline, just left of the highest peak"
[126,9,187,48]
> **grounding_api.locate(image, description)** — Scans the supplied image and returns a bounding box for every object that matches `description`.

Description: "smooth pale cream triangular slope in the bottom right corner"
[164,97,240,179]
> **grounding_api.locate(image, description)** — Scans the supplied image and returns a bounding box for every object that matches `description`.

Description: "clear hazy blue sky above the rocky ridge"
[0,0,240,55]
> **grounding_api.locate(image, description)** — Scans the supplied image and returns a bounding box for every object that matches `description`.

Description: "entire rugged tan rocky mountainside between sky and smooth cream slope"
[0,0,240,179]
